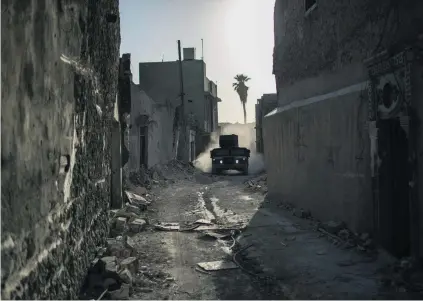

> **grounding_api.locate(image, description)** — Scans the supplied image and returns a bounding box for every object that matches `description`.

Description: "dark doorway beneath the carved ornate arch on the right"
[377,118,411,257]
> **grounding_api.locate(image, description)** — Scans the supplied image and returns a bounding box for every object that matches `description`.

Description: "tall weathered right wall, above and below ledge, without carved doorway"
[263,0,423,237]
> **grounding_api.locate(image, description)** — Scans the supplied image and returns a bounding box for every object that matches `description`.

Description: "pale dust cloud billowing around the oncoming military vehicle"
[194,123,264,174]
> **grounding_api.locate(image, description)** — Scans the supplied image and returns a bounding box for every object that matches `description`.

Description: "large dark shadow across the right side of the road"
[213,191,421,300]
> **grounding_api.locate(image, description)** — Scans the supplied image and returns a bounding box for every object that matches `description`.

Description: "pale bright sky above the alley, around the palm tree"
[120,0,276,122]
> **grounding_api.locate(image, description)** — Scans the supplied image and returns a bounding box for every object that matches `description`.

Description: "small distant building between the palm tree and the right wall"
[255,93,278,153]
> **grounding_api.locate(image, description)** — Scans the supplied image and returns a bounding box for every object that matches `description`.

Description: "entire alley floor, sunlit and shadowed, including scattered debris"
[82,162,420,300]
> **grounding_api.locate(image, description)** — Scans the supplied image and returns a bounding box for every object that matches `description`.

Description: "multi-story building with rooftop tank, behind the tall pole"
[139,48,221,159]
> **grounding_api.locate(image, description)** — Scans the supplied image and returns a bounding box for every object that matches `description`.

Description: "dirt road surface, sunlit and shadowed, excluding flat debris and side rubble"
[119,170,410,299]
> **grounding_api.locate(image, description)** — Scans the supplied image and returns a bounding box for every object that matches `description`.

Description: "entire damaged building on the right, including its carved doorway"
[263,0,423,257]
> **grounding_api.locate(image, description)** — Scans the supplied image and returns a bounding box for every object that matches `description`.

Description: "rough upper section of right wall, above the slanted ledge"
[273,0,423,89]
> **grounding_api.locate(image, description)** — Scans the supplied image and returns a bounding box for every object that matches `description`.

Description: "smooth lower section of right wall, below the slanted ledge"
[263,81,372,231]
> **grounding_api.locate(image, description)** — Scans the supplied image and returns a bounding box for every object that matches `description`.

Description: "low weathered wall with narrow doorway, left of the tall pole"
[129,84,175,171]
